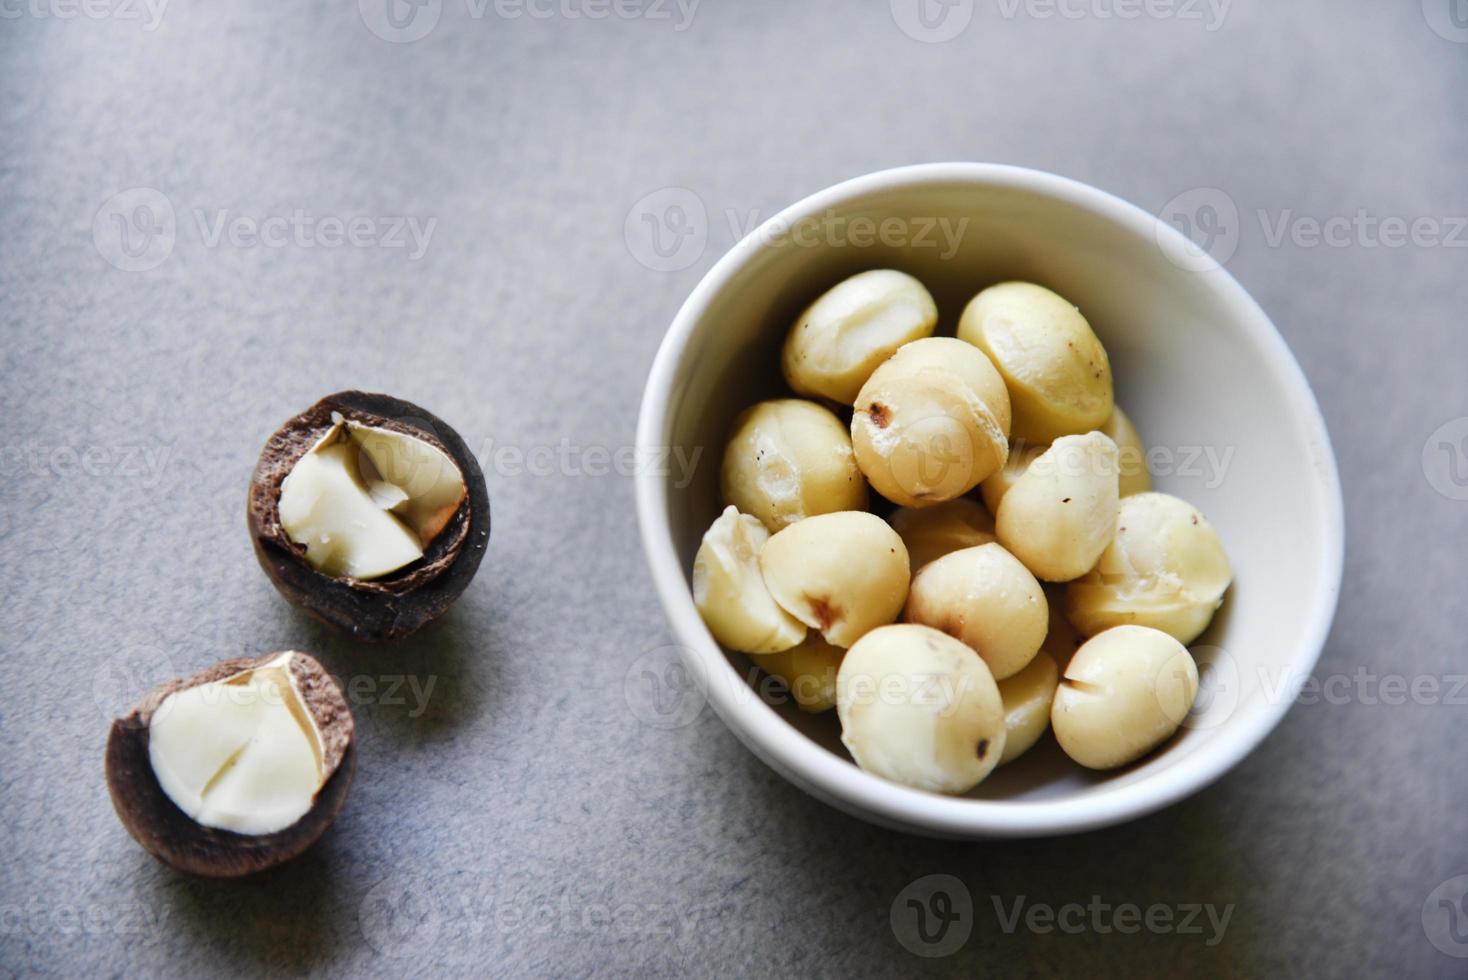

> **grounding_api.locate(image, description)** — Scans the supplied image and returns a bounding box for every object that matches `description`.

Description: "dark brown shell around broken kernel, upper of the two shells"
[247,392,489,643]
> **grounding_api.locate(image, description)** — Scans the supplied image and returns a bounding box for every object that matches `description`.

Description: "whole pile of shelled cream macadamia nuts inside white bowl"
[693,270,1233,794]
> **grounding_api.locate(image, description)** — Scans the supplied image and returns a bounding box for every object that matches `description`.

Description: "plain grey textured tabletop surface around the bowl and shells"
[0,0,1468,976]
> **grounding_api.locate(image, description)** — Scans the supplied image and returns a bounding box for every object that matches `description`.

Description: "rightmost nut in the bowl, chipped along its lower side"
[1066,493,1233,644]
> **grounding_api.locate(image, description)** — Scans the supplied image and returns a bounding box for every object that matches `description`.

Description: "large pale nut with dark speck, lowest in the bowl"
[837,625,1006,794]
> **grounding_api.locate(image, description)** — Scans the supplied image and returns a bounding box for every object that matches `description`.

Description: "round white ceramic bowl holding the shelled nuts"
[637,163,1343,838]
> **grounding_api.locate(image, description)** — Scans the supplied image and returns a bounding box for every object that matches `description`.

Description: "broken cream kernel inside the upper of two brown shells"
[280,415,467,581]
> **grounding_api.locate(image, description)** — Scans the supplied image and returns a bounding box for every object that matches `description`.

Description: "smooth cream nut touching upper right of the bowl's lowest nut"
[903,544,1050,681]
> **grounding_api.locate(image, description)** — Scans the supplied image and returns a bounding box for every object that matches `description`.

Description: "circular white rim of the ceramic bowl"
[636,163,1345,839]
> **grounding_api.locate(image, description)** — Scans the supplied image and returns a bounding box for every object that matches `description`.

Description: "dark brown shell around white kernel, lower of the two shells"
[106,653,357,877]
